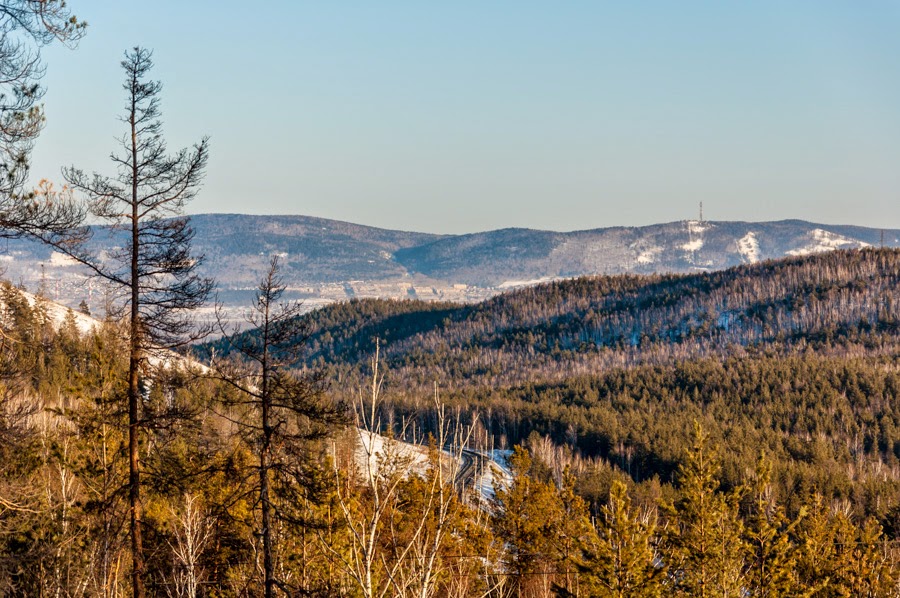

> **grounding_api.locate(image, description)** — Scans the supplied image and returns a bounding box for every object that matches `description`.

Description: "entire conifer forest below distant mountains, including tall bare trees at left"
[0,0,900,598]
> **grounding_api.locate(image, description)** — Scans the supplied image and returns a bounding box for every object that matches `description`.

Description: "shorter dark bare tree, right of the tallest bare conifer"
[210,256,345,598]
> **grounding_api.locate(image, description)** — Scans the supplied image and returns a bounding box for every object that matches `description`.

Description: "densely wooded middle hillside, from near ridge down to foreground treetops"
[202,250,900,516]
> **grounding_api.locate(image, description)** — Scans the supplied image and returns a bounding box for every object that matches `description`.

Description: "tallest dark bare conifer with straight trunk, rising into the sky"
[31,48,212,598]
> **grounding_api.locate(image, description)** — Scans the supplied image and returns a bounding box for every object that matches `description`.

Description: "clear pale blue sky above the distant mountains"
[32,0,900,233]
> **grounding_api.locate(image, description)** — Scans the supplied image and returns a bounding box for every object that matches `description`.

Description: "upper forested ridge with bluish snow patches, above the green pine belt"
[204,249,900,384]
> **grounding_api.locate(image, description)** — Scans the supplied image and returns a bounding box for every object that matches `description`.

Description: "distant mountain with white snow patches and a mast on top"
[396,220,900,286]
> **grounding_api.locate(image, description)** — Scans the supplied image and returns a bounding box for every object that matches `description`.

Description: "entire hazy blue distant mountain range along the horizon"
[0,214,900,308]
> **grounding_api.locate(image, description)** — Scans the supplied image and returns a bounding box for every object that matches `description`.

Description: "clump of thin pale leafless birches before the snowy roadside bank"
[320,344,474,598]
